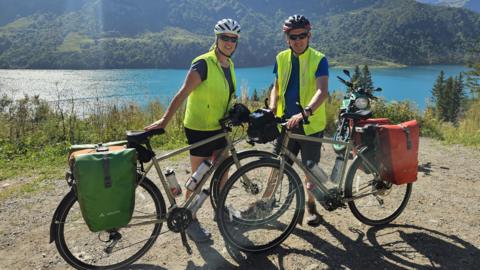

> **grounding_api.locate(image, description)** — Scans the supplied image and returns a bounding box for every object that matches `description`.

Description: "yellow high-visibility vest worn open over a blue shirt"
[277,48,327,135]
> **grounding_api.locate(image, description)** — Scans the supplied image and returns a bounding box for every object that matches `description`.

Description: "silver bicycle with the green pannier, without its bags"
[50,113,274,269]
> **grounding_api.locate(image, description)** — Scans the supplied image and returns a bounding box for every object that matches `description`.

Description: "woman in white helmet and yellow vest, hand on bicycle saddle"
[145,19,240,242]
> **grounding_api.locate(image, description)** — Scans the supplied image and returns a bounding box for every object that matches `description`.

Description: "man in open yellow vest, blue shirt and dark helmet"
[270,15,328,226]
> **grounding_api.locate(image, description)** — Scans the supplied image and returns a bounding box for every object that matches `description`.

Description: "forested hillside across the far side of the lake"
[0,0,480,68]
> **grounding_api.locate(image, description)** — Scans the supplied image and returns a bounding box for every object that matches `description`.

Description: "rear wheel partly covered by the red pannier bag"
[345,153,412,226]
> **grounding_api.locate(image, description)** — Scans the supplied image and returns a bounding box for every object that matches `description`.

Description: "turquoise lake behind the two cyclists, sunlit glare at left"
[0,65,468,109]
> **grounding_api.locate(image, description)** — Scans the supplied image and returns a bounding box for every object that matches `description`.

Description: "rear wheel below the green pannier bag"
[51,178,165,269]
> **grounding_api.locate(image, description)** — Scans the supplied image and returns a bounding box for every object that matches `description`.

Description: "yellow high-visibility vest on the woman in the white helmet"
[183,50,237,131]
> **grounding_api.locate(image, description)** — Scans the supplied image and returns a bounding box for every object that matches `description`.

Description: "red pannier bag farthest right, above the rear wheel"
[375,120,420,185]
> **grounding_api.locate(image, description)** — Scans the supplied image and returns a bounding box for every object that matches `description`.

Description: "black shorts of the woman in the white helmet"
[185,128,227,157]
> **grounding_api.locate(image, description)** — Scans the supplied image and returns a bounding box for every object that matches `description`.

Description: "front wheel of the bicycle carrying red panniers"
[216,158,305,252]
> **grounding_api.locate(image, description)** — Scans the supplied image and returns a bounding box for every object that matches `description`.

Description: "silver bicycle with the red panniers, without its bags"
[216,111,412,252]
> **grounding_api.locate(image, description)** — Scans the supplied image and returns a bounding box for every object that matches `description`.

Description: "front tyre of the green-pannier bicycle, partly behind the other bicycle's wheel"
[210,150,277,211]
